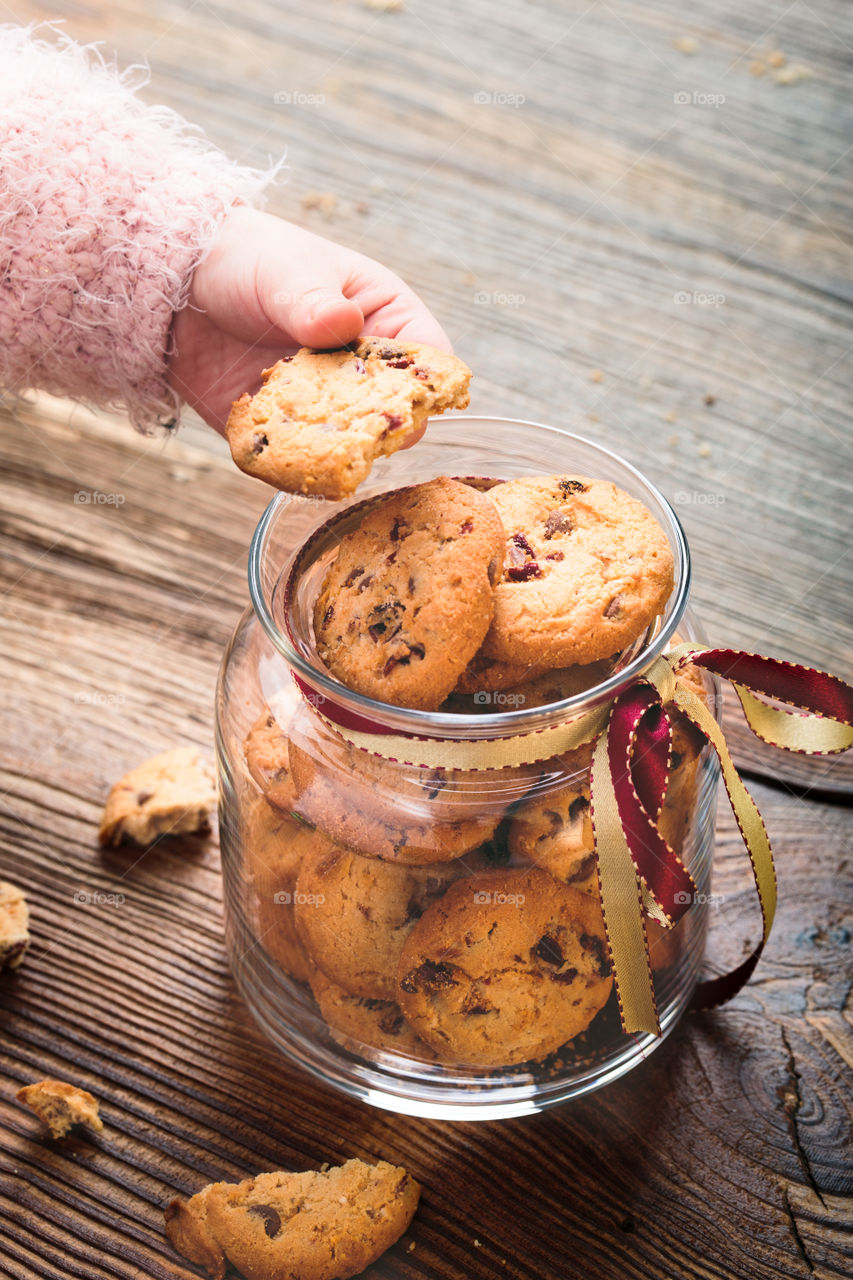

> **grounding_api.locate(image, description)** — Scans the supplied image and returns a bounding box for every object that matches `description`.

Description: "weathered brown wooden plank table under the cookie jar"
[0,0,853,1280]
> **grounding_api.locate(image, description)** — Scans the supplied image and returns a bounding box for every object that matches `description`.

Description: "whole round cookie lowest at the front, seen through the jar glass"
[397,867,612,1068]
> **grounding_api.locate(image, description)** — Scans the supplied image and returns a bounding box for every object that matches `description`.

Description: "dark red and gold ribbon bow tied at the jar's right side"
[589,644,853,1036]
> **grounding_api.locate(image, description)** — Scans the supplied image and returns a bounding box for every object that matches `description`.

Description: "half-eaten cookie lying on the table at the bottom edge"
[165,1160,420,1280]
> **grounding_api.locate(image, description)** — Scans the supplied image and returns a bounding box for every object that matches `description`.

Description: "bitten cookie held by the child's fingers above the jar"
[225,338,471,498]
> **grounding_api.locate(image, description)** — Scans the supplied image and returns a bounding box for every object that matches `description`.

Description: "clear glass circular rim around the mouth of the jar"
[248,413,690,739]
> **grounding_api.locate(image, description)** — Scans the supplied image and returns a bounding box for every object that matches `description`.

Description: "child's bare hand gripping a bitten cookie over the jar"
[169,209,451,431]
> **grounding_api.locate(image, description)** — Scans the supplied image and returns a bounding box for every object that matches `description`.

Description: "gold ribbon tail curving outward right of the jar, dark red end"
[675,686,776,1009]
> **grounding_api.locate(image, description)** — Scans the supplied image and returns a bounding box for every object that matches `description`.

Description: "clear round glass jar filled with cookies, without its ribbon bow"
[216,417,719,1120]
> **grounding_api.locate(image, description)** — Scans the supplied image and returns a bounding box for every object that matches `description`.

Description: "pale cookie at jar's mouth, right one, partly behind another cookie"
[483,475,674,667]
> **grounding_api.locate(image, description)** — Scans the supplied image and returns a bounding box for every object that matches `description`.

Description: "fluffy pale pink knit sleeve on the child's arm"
[0,27,275,430]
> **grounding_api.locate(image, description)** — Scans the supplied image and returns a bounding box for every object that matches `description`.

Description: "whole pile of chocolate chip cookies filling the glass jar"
[235,475,706,1071]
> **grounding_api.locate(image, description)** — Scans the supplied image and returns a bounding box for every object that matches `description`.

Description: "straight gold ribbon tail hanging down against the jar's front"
[589,728,661,1036]
